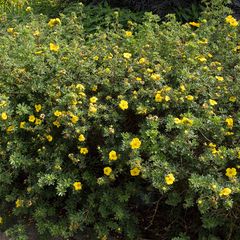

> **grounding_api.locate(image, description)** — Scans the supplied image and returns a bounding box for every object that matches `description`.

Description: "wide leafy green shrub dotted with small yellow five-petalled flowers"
[0,0,240,239]
